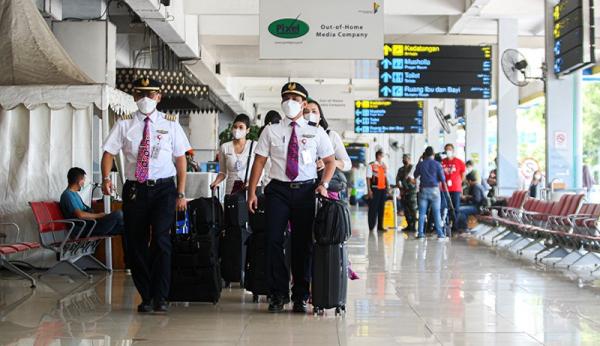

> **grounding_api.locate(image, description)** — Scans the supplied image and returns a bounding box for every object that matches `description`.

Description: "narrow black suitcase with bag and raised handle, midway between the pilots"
[219,142,254,287]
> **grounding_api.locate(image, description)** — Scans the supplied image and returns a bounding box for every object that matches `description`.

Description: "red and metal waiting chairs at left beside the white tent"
[0,201,110,287]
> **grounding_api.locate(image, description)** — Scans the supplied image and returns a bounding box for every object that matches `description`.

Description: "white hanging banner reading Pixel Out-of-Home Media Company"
[259,0,383,60]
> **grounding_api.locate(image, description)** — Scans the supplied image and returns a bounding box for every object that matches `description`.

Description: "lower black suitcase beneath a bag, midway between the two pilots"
[219,226,249,287]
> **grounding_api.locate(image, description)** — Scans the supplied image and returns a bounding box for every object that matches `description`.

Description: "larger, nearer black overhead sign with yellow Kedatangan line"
[379,44,492,99]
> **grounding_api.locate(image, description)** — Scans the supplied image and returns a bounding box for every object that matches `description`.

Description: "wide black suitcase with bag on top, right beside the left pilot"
[169,190,223,304]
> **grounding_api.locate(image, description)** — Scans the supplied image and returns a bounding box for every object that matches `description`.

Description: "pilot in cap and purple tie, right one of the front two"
[248,82,335,313]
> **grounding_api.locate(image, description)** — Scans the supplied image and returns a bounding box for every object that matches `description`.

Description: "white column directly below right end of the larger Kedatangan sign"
[465,100,489,178]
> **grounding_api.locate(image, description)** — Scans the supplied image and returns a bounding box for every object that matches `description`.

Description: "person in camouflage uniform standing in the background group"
[396,154,418,232]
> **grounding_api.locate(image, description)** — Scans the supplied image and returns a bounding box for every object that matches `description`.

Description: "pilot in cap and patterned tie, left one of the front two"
[102,78,191,313]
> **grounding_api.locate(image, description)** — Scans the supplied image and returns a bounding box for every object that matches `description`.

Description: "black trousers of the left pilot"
[123,181,177,302]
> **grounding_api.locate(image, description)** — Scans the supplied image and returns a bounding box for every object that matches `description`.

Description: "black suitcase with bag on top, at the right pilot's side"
[312,197,351,315]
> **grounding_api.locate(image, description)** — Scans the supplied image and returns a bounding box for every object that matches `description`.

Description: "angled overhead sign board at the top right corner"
[552,0,595,76]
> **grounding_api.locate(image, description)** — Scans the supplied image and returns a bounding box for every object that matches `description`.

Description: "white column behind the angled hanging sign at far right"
[546,0,583,188]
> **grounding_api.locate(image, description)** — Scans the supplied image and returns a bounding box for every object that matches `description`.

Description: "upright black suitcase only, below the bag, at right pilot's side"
[312,243,348,315]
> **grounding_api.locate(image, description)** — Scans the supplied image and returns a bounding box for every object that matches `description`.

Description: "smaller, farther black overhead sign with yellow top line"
[354,100,423,133]
